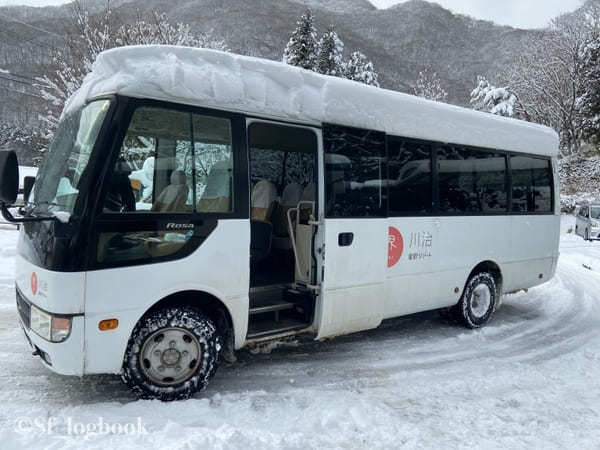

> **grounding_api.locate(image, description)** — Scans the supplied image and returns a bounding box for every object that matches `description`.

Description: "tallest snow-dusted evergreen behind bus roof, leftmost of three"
[283,9,319,70]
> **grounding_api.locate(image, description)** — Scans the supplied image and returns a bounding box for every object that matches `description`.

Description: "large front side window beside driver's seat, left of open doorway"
[104,107,233,213]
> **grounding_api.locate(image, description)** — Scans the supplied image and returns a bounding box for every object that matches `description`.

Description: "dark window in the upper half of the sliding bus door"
[323,125,387,218]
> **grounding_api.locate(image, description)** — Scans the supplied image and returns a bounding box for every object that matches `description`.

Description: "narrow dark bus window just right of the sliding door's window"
[388,140,433,216]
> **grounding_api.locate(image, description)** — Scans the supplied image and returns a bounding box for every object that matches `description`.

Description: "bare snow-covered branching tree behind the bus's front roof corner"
[37,0,227,139]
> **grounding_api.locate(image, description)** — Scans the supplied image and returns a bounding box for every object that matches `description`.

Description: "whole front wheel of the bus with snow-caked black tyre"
[122,306,221,401]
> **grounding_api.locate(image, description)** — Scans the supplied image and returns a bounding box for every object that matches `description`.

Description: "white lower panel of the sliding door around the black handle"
[317,219,387,339]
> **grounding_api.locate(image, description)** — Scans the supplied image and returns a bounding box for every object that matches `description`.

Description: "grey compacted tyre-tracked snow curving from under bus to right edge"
[209,253,600,390]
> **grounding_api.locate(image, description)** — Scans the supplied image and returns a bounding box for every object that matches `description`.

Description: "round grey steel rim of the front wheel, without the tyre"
[140,328,202,386]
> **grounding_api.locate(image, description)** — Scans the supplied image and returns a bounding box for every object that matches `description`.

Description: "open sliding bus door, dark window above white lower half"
[315,125,388,339]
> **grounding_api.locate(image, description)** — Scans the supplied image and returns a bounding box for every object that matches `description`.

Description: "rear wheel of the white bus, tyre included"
[455,272,498,328]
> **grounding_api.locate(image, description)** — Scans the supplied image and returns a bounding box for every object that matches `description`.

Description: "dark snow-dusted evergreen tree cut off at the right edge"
[577,35,600,142]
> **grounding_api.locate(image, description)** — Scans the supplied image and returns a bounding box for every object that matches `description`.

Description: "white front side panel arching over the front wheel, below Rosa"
[85,220,250,373]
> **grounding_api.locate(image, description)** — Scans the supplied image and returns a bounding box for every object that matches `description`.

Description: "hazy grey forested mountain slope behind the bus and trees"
[0,0,536,112]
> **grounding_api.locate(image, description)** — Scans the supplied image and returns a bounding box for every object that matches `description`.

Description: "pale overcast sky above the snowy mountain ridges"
[0,0,583,28]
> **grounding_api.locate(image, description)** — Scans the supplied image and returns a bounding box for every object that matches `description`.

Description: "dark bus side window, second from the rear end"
[437,146,508,213]
